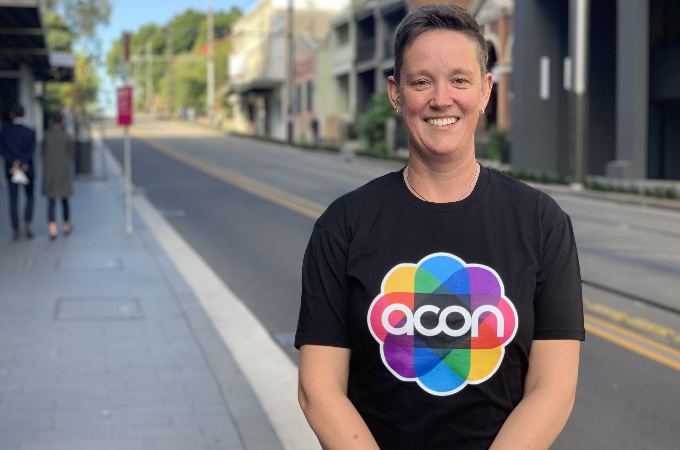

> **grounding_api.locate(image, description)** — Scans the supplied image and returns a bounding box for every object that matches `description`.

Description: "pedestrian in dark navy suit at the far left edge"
[0,104,35,241]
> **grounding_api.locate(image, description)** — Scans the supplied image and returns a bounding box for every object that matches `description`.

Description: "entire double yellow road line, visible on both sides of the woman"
[131,129,680,370]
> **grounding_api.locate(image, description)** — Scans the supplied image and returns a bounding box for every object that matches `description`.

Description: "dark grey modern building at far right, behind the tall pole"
[512,0,680,179]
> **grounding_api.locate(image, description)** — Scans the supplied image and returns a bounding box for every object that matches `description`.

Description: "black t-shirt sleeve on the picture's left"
[295,223,350,349]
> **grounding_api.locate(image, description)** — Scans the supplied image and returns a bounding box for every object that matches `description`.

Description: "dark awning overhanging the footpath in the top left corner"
[0,0,75,81]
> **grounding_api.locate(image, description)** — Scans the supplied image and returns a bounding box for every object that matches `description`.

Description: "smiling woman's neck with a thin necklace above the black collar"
[404,151,479,203]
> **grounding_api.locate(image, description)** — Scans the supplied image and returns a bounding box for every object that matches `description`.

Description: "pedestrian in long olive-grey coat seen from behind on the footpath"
[43,113,75,240]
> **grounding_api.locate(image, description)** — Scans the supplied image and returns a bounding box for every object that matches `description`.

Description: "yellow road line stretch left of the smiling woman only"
[130,129,326,220]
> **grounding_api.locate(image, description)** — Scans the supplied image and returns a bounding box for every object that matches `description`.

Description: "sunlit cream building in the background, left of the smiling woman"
[229,0,344,140]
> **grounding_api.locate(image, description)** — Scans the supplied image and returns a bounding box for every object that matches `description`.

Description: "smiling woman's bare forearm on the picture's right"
[489,340,581,450]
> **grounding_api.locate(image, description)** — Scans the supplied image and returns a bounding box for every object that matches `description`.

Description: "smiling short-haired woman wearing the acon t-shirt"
[295,5,585,450]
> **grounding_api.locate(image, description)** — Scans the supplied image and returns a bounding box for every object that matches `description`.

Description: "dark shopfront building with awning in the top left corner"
[0,0,76,142]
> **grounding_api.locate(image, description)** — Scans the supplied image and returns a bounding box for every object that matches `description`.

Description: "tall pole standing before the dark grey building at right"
[570,0,590,189]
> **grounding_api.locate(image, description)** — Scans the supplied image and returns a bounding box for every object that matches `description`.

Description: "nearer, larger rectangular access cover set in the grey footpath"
[54,297,144,320]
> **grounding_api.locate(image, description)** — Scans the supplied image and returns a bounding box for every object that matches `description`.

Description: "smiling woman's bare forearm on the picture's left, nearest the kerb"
[298,345,379,450]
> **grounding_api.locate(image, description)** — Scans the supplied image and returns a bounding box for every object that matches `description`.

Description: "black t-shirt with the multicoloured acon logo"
[295,168,585,450]
